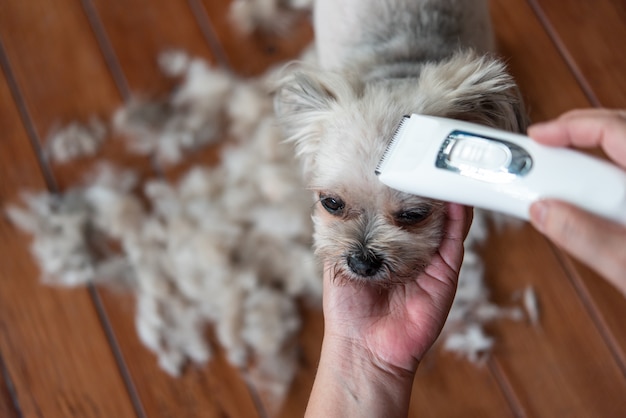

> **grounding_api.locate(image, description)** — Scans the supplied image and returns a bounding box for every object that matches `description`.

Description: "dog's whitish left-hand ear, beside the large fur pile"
[274,69,354,172]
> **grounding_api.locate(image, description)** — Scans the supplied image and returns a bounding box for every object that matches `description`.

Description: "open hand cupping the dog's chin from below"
[323,204,473,376]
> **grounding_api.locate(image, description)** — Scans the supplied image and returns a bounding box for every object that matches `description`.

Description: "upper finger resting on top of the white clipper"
[528,109,626,168]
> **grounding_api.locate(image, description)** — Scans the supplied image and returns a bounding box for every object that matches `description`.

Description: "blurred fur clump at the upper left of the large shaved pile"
[113,51,235,164]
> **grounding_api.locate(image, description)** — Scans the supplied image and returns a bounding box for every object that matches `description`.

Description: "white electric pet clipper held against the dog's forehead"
[376,114,626,225]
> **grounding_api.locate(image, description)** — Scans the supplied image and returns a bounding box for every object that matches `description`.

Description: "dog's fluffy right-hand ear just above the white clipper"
[420,53,529,133]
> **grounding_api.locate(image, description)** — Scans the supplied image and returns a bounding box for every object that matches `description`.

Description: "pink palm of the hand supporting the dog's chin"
[325,258,455,370]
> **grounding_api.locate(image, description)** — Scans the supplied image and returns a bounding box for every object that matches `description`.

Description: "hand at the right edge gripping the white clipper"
[528,109,626,295]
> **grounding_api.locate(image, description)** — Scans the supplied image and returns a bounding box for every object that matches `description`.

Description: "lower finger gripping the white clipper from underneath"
[530,200,626,295]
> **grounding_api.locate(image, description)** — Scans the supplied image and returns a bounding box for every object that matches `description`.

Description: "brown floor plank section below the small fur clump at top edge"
[201,0,313,76]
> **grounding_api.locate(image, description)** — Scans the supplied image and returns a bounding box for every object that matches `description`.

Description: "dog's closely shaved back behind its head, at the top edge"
[314,0,494,72]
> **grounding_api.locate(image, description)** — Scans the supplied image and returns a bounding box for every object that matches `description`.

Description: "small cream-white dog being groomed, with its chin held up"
[275,0,528,286]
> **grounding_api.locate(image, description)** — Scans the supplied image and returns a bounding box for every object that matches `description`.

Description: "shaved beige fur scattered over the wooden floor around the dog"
[5,2,537,399]
